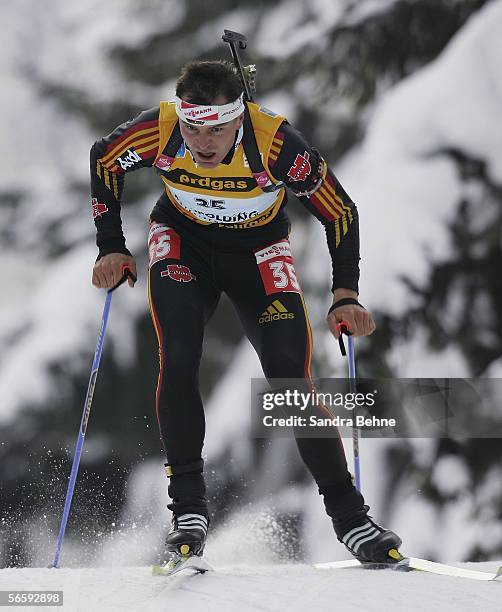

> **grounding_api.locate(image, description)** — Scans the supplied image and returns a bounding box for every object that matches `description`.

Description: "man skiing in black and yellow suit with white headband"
[91,61,401,562]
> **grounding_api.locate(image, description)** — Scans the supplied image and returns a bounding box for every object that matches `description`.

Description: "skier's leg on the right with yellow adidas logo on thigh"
[218,240,364,520]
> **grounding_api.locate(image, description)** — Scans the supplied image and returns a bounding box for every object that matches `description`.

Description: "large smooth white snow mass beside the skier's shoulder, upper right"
[339,2,502,322]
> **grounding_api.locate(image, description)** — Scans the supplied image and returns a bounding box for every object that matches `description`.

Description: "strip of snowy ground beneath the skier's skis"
[0,558,502,612]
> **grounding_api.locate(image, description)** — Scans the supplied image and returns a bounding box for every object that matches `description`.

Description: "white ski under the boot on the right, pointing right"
[314,557,502,581]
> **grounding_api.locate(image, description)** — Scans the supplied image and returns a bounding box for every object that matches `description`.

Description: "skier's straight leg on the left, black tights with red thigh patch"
[149,224,220,515]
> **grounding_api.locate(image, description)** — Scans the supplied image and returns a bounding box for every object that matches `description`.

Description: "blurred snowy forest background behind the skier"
[0,0,502,567]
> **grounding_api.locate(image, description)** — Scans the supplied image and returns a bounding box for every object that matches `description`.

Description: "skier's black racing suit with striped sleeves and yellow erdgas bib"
[91,103,362,518]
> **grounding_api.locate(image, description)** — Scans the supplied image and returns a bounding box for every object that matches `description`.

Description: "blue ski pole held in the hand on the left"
[49,265,136,568]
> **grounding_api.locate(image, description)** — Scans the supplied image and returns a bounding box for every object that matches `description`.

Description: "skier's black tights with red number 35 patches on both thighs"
[149,226,353,514]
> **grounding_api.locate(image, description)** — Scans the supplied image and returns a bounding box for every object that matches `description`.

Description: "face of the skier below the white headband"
[180,97,244,168]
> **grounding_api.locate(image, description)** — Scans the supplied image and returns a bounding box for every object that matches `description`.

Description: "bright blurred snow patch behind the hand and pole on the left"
[0,245,147,424]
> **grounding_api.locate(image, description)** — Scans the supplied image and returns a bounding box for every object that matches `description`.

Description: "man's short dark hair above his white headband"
[176,60,244,104]
